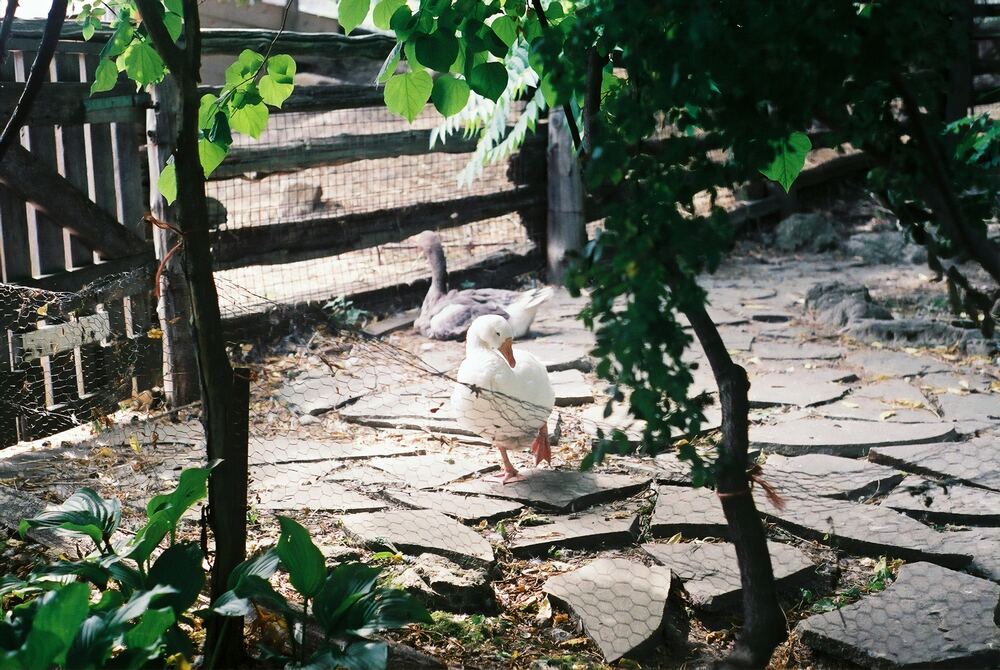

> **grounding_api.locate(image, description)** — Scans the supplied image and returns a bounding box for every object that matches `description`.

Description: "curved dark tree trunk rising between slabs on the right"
[684,288,788,668]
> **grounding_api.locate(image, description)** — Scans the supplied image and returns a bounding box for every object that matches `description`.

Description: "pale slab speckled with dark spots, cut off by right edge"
[882,475,1000,528]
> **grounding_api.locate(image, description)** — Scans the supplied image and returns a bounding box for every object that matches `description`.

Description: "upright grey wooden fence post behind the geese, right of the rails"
[546,109,587,284]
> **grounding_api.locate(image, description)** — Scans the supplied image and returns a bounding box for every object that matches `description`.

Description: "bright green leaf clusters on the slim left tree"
[77,0,296,202]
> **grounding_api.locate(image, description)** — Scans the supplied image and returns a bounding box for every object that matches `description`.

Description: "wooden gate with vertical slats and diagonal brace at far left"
[0,27,160,446]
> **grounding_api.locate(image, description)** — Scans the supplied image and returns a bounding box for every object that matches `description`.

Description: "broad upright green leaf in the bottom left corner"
[17,582,90,668]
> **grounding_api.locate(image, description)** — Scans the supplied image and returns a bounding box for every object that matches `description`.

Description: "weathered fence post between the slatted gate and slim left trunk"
[146,84,201,407]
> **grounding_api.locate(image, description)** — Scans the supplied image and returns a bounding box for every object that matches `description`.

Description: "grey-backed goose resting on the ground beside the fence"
[413,230,552,340]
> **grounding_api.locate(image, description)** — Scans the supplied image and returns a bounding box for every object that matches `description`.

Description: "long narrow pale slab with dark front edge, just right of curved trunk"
[750,418,957,457]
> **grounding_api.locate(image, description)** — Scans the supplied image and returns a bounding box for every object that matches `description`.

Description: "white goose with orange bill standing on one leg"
[451,315,555,484]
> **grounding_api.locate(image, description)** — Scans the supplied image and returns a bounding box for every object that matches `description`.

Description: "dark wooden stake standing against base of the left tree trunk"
[205,368,251,668]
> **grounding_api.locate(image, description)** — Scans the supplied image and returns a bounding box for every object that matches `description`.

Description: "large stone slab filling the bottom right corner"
[795,563,1000,668]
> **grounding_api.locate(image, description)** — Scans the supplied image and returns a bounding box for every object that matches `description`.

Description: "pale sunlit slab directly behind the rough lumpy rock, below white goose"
[340,509,493,564]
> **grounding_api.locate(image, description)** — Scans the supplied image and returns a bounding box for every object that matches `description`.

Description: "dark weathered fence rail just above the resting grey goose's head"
[212,189,545,270]
